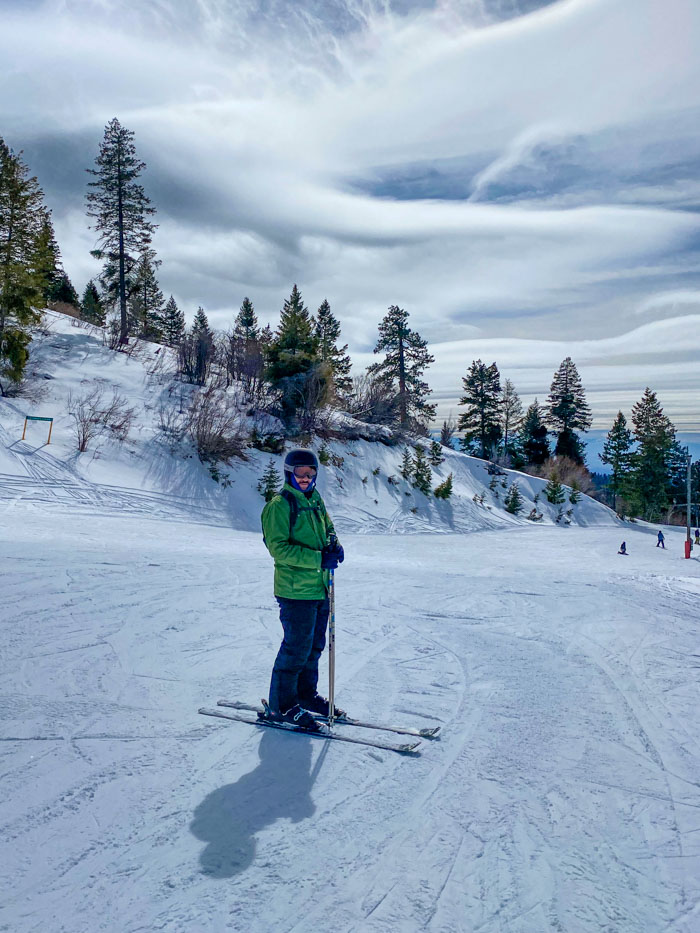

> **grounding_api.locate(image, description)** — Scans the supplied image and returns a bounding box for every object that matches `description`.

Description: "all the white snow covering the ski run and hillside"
[0,314,700,933]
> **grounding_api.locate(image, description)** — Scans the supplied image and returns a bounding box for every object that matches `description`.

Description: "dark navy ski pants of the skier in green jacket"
[270,596,329,713]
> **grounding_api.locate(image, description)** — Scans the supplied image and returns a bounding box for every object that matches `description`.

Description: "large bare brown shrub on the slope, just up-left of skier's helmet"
[185,387,247,463]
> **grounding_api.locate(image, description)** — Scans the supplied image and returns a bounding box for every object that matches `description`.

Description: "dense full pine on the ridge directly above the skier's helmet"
[265,285,330,430]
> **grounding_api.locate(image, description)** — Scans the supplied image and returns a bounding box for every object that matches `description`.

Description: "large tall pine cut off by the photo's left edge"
[0,139,46,395]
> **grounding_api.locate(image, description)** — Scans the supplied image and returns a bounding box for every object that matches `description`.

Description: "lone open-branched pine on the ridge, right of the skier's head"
[367,305,437,432]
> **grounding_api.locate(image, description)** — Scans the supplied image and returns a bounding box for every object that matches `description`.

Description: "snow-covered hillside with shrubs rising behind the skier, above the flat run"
[0,312,617,533]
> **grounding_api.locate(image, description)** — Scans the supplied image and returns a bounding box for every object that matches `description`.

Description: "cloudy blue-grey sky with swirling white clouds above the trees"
[0,0,700,431]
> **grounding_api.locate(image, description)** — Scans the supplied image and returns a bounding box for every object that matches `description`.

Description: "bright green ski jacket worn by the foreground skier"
[262,483,335,599]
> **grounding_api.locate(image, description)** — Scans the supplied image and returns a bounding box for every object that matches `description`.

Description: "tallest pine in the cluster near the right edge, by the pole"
[626,387,676,521]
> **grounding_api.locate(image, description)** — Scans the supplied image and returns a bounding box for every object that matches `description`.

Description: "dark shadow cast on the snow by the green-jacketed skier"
[190,730,323,878]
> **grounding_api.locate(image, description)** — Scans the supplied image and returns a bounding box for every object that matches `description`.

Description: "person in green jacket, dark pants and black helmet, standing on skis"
[262,449,345,732]
